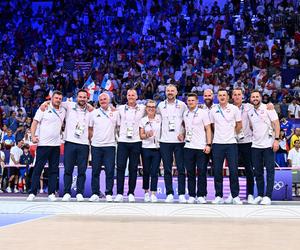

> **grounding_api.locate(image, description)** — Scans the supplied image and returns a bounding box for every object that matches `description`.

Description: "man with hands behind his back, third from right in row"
[210,89,242,204]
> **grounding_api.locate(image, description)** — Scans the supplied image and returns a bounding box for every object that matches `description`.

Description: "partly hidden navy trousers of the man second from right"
[238,142,254,195]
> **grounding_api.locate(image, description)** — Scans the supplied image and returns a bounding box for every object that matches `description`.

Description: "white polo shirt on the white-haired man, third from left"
[89,108,119,147]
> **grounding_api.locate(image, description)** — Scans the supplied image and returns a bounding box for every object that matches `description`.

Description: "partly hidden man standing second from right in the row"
[231,88,254,204]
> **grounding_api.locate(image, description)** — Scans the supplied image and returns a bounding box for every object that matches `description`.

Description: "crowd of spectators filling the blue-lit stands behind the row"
[0,0,300,193]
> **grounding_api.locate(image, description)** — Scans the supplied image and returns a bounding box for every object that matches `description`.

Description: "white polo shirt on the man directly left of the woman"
[117,104,145,142]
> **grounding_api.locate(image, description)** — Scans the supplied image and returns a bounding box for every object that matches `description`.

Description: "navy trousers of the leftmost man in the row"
[30,146,60,195]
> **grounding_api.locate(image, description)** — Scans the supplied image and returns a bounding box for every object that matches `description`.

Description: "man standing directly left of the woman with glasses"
[114,89,145,202]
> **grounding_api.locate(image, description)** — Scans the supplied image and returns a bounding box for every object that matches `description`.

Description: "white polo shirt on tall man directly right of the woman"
[157,99,187,143]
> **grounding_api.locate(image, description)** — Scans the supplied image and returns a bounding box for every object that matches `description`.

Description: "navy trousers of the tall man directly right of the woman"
[160,142,185,195]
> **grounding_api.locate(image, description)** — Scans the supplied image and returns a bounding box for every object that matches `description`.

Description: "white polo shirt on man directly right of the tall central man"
[183,108,210,149]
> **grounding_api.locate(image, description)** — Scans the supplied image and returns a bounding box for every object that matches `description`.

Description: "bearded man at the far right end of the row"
[248,90,280,205]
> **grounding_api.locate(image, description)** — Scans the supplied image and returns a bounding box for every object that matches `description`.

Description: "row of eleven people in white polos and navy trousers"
[27,84,280,205]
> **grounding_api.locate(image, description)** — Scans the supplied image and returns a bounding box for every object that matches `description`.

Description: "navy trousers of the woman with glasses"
[142,148,161,192]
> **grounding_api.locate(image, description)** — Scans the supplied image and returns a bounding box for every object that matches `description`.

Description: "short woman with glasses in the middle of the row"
[140,100,161,202]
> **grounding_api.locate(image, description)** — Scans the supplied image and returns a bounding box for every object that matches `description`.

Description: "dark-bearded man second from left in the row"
[62,89,90,202]
